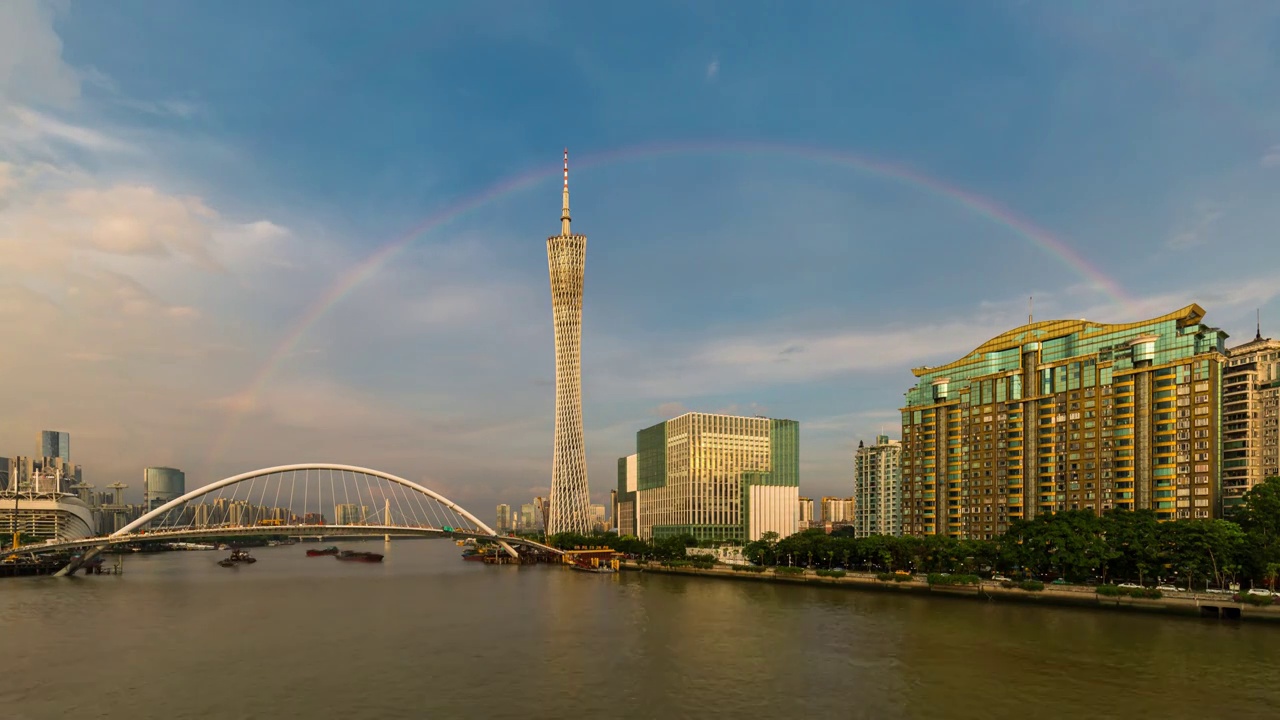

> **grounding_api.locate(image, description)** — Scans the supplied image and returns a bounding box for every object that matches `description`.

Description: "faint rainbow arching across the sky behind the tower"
[206,142,1133,466]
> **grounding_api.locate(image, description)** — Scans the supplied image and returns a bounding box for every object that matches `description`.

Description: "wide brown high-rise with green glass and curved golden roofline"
[902,305,1226,538]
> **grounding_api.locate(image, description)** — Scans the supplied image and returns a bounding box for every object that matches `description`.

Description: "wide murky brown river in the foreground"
[0,541,1280,720]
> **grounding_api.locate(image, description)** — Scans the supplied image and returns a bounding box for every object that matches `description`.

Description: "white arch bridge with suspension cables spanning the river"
[10,462,561,575]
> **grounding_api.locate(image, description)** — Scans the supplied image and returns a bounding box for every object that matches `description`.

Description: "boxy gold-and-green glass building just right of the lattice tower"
[629,413,800,542]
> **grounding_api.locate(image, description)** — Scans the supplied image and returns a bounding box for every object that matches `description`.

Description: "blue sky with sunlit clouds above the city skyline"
[0,0,1280,520]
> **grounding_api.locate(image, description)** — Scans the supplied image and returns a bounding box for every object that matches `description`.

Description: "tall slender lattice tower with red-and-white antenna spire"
[547,150,591,536]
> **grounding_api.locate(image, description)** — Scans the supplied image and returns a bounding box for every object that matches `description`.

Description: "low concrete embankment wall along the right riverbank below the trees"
[622,562,1280,623]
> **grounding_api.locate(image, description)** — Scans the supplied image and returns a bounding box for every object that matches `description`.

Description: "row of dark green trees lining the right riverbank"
[549,478,1280,589]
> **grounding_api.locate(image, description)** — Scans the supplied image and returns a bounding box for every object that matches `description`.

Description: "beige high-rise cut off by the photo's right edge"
[1218,323,1280,514]
